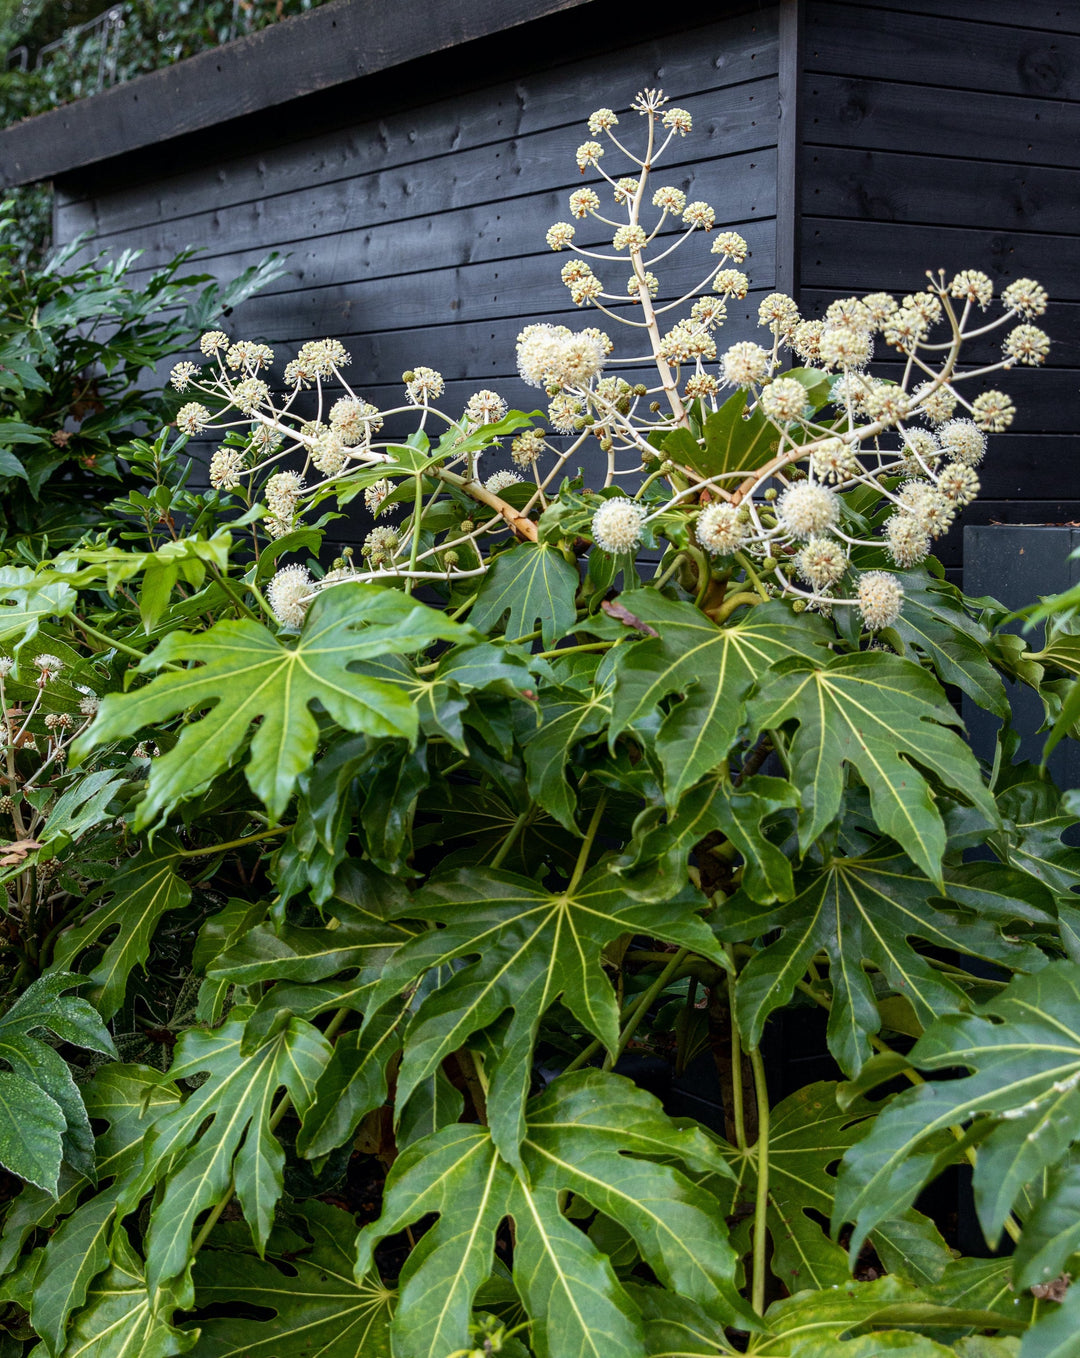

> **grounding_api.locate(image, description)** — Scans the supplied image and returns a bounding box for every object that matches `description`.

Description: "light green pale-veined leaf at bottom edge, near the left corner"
[50,1230,198,1358]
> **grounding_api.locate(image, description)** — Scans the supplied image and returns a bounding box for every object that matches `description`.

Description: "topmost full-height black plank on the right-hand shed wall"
[804,0,1080,103]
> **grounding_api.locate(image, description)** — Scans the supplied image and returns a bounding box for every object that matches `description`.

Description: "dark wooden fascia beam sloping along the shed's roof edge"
[0,0,592,187]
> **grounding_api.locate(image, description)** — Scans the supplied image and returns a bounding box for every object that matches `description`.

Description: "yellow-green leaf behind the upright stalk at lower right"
[721,1082,951,1293]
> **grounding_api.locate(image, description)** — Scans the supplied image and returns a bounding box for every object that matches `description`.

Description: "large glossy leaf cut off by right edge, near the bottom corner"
[834,961,1080,1262]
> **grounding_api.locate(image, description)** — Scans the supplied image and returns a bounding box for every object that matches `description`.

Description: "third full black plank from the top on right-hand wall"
[803,147,1080,239]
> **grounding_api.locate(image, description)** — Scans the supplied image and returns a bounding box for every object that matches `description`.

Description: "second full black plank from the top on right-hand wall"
[803,73,1080,168]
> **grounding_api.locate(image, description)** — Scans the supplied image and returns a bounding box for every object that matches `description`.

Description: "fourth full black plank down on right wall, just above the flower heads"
[802,216,1080,301]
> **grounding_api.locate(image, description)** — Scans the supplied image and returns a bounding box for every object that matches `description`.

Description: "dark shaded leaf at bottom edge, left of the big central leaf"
[194,1202,394,1358]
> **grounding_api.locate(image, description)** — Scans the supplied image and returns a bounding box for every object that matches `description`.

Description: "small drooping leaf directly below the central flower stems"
[469,542,579,646]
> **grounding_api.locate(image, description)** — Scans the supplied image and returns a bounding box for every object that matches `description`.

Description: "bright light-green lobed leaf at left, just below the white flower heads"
[77,584,469,828]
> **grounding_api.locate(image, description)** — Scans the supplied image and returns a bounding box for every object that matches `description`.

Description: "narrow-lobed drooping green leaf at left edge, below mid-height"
[56,835,192,1019]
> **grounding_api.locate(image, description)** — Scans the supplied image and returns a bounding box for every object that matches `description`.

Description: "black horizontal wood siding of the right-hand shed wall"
[800,0,1080,566]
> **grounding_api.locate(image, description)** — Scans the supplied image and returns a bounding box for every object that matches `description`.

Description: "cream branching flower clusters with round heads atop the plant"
[173,90,1049,631]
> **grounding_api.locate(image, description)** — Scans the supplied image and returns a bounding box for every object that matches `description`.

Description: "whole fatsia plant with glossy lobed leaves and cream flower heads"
[0,82,1080,1358]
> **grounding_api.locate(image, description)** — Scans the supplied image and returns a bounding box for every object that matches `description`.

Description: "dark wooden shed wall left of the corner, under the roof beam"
[56,4,778,513]
